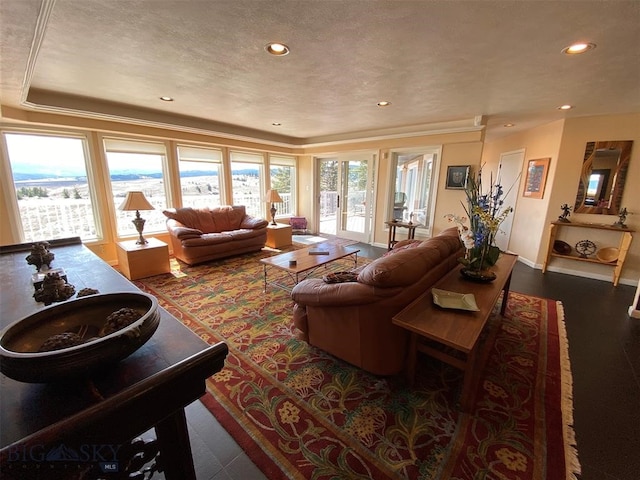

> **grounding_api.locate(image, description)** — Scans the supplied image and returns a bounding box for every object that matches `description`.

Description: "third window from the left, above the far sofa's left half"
[178,145,224,208]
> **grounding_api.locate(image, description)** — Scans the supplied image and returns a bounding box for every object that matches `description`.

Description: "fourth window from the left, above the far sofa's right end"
[230,152,266,217]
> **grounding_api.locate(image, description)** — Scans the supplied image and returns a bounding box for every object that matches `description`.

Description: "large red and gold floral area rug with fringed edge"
[135,246,580,480]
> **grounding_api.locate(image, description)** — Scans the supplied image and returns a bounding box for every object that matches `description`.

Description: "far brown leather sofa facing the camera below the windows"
[162,205,269,265]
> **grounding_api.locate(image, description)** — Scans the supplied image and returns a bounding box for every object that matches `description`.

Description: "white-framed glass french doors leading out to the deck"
[316,154,375,243]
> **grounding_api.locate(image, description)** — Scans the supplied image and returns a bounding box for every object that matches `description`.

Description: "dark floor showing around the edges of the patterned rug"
[172,244,640,480]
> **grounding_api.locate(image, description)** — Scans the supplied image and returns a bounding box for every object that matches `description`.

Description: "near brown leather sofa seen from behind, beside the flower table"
[291,227,463,375]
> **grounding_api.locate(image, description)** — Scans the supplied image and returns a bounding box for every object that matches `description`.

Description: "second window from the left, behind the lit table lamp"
[104,138,168,237]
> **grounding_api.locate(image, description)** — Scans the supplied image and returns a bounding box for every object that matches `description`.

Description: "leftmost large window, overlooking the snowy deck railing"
[3,132,100,242]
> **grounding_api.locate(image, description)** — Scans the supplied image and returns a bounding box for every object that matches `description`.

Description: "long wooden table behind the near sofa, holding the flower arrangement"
[392,253,518,410]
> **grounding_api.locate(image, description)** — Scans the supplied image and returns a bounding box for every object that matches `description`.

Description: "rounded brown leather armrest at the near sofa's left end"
[291,278,402,307]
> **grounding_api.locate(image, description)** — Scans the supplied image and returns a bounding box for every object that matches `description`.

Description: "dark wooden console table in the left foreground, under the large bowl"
[0,239,228,480]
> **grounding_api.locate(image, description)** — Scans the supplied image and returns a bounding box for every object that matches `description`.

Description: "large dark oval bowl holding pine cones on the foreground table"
[0,292,160,383]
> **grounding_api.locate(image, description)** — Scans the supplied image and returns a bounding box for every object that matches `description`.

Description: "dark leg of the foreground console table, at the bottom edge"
[155,408,196,480]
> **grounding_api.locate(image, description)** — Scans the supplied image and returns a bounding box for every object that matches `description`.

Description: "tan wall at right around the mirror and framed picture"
[482,114,640,285]
